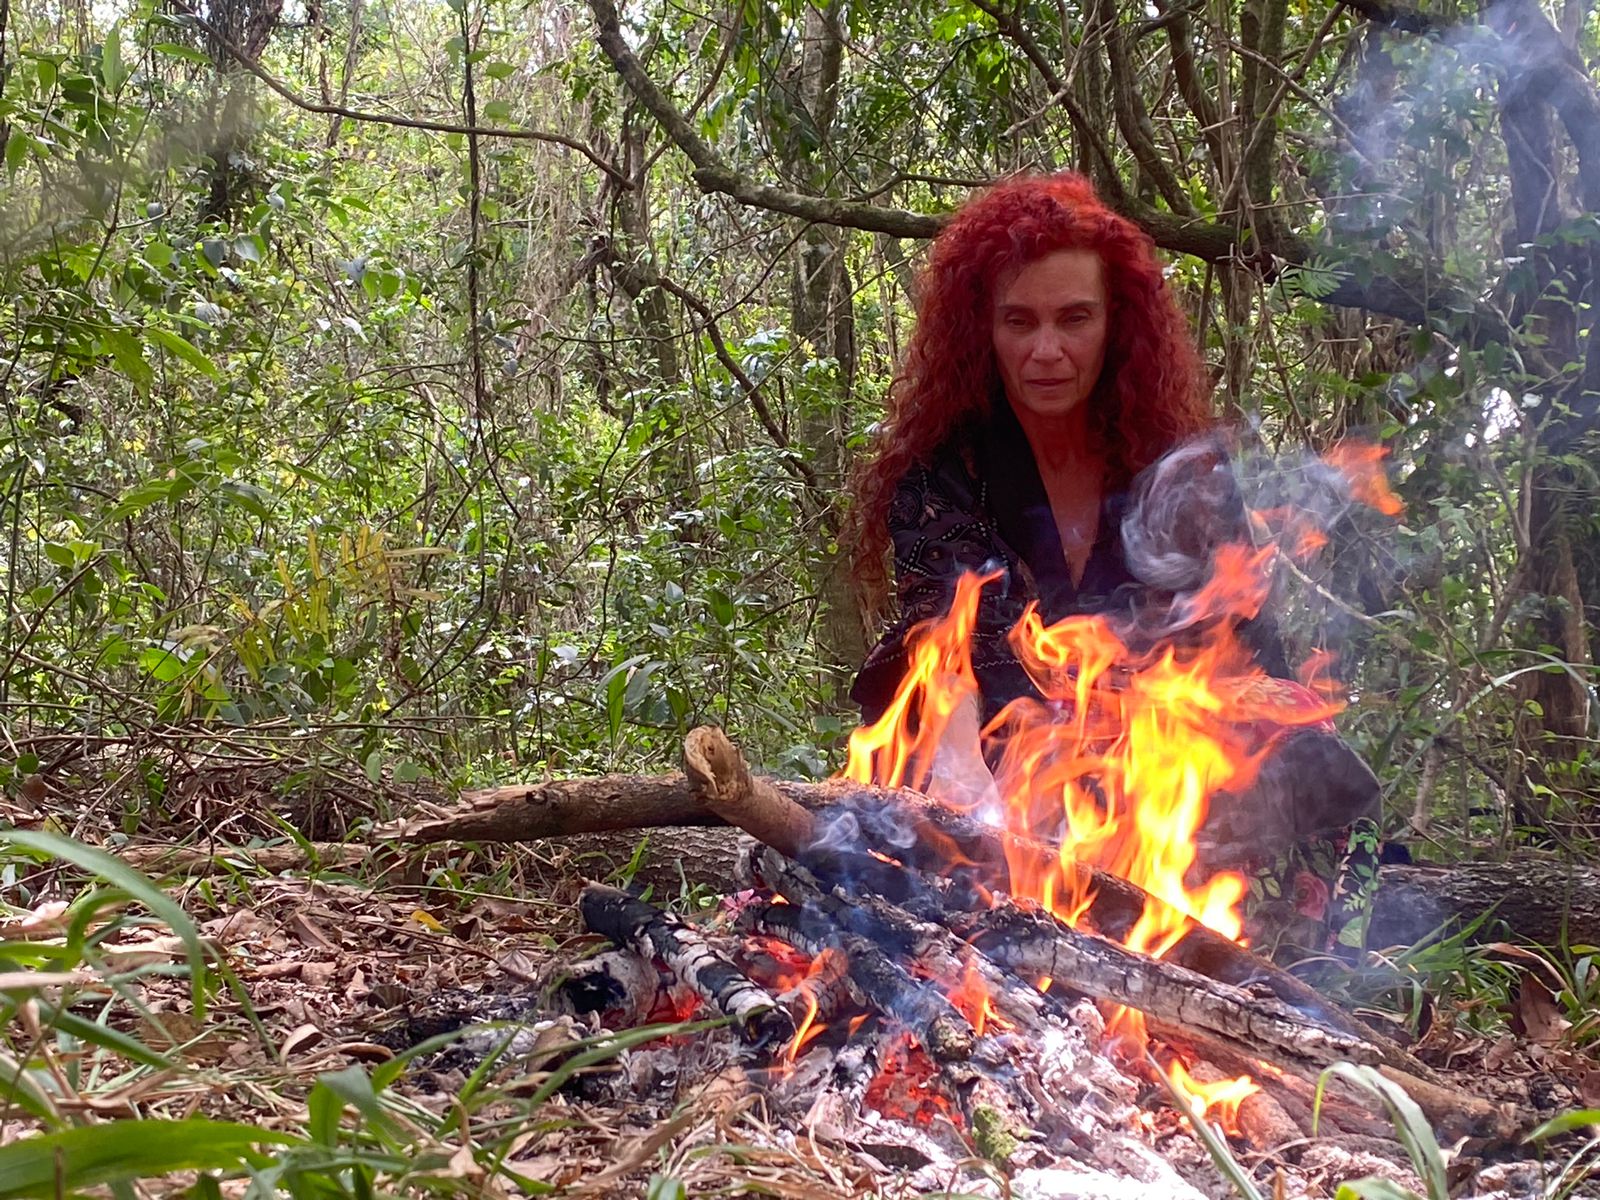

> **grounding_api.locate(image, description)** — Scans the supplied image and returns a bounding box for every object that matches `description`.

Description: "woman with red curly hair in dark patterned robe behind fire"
[851,174,1378,960]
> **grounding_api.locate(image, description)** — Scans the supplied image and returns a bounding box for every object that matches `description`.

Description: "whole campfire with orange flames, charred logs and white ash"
[390,448,1526,1194]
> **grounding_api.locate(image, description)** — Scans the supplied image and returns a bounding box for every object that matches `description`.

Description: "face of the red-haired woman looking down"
[994,250,1109,419]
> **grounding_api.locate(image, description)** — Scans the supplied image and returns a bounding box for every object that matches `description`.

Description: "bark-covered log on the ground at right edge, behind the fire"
[1366,859,1600,946]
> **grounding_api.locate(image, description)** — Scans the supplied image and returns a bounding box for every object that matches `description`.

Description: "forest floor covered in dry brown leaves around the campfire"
[0,761,1600,1198]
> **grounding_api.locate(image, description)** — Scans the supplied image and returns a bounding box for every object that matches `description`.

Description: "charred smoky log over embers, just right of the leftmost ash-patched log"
[739,904,974,1062]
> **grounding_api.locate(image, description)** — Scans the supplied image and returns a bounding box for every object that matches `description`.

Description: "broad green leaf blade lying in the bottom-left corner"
[0,1117,304,1200]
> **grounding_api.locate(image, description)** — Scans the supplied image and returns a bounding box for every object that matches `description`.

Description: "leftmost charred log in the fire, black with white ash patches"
[578,883,795,1046]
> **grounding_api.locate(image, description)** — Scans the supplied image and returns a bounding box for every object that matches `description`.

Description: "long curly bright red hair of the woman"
[851,171,1210,613]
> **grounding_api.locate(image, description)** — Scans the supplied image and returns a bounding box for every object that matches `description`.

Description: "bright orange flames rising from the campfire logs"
[843,442,1400,1081]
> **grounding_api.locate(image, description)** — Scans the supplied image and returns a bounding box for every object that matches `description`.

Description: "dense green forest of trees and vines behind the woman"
[0,0,1600,854]
